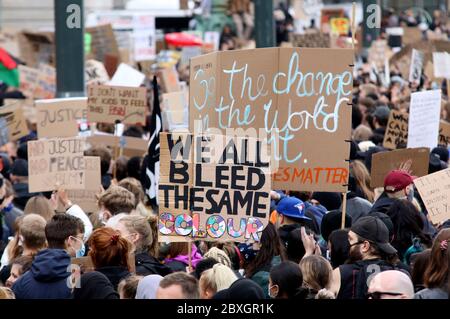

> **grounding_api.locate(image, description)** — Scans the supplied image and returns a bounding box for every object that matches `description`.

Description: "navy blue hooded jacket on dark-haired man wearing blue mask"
[12,249,71,299]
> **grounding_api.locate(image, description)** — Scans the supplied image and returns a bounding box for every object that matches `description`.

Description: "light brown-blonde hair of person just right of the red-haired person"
[119,215,158,257]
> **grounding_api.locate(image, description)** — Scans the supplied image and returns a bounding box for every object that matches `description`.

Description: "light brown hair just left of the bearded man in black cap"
[300,255,333,291]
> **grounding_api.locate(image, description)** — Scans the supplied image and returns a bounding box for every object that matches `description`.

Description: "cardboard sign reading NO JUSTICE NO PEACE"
[28,137,89,193]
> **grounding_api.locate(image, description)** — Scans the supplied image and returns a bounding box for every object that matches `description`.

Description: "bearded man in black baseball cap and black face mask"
[331,216,410,299]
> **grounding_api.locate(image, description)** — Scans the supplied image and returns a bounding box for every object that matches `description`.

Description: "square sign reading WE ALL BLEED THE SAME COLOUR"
[158,133,271,242]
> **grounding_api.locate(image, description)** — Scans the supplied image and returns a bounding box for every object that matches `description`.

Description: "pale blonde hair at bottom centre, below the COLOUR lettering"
[200,264,237,293]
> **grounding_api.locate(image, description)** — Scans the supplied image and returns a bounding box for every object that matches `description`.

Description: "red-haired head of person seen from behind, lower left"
[88,227,131,270]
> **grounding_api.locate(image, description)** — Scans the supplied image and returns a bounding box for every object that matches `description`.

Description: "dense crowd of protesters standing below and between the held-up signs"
[0,4,450,299]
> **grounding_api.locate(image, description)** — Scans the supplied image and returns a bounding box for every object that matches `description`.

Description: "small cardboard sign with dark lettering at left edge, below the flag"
[0,104,29,145]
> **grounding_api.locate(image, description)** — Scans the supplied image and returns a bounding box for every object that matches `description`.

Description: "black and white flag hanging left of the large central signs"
[141,76,162,206]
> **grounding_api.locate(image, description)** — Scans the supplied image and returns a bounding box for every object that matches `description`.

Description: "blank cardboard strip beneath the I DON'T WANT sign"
[86,134,148,157]
